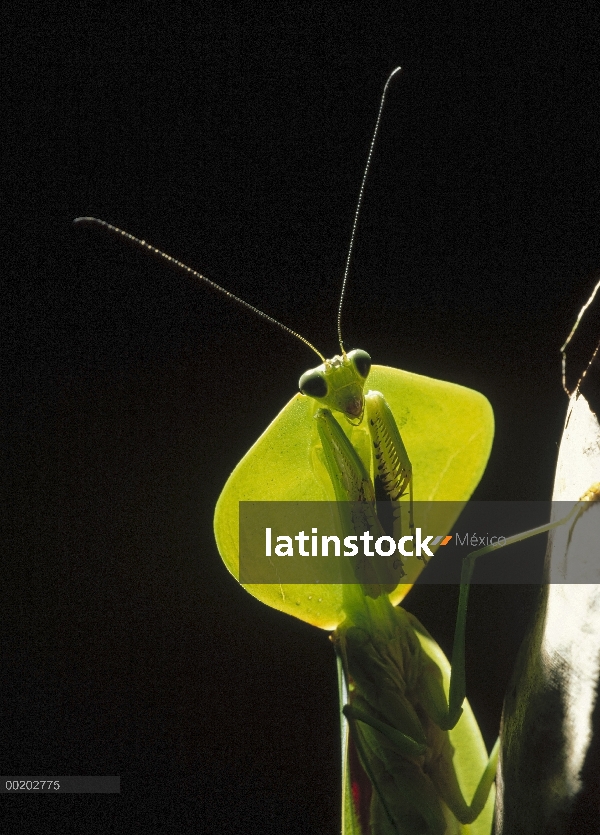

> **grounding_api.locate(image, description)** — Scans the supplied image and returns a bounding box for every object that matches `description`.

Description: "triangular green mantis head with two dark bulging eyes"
[298,348,371,426]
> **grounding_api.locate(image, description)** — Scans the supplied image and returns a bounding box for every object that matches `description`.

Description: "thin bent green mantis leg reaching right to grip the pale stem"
[446,482,600,729]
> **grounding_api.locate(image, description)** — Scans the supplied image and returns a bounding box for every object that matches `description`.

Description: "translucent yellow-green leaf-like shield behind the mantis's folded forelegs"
[214,366,494,630]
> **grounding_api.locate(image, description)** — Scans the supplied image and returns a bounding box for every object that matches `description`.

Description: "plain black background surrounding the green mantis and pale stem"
[0,2,600,833]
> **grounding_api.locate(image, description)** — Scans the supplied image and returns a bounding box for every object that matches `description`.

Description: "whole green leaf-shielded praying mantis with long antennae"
[75,68,596,835]
